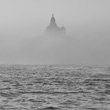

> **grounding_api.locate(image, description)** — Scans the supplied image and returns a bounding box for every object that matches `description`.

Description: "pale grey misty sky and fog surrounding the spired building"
[0,0,110,64]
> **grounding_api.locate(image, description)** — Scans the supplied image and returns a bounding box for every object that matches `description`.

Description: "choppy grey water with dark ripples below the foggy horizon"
[0,65,110,110]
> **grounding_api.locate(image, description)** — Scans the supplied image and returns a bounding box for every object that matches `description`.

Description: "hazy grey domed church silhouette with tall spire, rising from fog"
[45,14,66,36]
